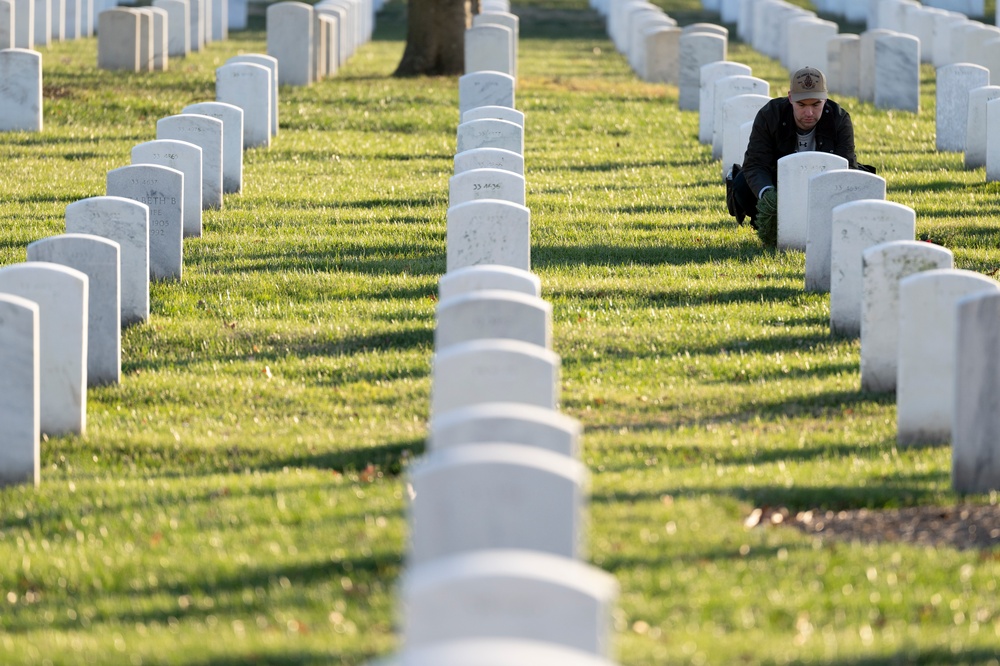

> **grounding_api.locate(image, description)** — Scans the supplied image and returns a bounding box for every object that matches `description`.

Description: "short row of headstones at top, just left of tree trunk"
[267,0,374,86]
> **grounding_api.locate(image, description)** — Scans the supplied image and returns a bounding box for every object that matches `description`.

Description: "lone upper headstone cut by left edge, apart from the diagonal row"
[0,49,42,132]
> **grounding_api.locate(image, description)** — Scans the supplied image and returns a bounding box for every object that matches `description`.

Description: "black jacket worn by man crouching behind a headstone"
[743,97,858,196]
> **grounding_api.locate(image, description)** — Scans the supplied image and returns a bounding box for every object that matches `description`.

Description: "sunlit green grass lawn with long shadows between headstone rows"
[0,0,1000,666]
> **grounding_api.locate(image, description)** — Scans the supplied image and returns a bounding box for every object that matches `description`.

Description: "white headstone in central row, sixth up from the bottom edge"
[434,289,552,351]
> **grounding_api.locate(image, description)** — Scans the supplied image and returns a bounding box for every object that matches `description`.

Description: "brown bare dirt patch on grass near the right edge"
[745,504,1000,557]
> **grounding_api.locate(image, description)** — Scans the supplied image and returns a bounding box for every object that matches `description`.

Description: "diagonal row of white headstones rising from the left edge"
[0,54,277,484]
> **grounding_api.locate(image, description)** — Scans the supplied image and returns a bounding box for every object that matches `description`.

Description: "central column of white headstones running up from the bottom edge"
[378,16,618,666]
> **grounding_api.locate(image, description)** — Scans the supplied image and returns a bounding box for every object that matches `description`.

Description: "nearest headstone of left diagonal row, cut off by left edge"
[0,289,41,487]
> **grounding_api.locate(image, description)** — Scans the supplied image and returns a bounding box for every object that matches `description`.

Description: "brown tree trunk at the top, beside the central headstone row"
[393,0,479,76]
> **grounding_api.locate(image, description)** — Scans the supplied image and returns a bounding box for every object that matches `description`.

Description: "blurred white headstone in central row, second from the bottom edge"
[401,548,618,657]
